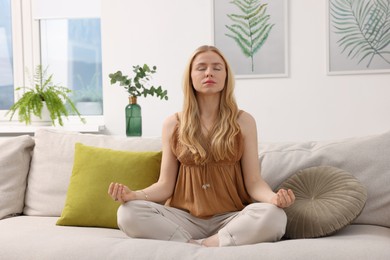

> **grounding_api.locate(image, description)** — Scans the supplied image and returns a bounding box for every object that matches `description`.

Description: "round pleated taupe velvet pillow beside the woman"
[279,166,367,238]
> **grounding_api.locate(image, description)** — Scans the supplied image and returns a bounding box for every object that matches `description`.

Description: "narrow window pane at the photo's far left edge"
[0,0,14,110]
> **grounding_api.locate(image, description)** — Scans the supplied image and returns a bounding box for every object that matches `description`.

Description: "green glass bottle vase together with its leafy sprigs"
[109,64,168,136]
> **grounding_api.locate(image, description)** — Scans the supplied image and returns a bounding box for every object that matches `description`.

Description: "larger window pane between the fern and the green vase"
[40,18,103,115]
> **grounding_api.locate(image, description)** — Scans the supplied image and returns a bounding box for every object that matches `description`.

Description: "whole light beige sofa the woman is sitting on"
[0,129,390,260]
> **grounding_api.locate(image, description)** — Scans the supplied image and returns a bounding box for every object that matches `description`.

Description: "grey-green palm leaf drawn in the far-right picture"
[330,0,390,68]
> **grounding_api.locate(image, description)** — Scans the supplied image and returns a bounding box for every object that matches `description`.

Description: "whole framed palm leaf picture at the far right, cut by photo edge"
[326,0,390,75]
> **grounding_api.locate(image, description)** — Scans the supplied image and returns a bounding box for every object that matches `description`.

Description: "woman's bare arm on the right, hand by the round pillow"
[238,112,295,208]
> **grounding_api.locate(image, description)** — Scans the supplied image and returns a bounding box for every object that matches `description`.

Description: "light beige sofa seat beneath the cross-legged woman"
[0,216,390,260]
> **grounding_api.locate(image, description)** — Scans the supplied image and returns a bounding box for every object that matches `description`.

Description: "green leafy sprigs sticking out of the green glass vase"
[108,64,168,100]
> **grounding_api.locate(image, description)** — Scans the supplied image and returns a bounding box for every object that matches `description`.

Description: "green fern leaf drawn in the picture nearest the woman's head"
[225,0,274,72]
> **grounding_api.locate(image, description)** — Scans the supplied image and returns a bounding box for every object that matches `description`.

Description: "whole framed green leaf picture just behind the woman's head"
[212,0,289,79]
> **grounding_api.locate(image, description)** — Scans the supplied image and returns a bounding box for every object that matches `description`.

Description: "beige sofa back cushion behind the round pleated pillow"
[259,132,390,227]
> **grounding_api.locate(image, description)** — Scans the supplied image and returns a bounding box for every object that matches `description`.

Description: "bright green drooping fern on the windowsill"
[7,65,85,126]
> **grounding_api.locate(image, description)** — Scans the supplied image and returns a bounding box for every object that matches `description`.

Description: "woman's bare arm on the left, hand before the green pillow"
[108,115,179,203]
